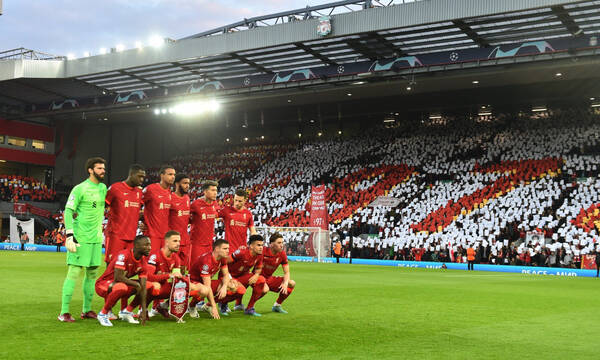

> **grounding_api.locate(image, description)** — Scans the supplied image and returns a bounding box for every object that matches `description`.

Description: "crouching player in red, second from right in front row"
[221,235,269,316]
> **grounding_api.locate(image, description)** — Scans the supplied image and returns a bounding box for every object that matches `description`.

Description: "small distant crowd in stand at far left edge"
[0,175,56,202]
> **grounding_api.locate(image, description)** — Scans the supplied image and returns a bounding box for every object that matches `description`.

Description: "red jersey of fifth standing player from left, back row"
[190,199,219,246]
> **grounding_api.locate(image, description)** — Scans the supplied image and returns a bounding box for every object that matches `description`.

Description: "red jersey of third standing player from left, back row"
[143,183,171,238]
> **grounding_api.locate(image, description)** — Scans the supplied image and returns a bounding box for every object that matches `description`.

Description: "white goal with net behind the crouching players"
[256,226,331,262]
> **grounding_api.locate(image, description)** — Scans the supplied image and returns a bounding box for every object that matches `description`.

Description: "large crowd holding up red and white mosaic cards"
[136,105,600,267]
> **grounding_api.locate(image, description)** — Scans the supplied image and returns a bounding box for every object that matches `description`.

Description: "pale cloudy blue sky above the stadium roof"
[0,0,331,57]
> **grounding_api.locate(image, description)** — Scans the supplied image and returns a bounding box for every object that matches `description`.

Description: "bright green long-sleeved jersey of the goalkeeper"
[65,179,106,243]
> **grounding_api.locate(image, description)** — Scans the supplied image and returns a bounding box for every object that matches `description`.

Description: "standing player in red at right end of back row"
[219,189,256,253]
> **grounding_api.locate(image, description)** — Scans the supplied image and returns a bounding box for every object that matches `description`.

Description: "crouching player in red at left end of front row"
[96,235,152,326]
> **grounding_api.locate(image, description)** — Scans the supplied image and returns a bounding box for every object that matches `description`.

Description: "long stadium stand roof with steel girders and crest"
[0,0,600,116]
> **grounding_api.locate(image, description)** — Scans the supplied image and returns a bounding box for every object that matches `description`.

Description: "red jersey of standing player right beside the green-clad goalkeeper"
[105,181,142,240]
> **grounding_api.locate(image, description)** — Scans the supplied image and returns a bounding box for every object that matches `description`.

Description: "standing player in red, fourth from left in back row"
[165,174,191,272]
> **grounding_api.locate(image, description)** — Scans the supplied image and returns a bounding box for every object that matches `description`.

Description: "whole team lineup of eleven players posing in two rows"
[58,157,295,326]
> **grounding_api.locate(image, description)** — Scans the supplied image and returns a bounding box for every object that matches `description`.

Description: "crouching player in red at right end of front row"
[261,233,296,314]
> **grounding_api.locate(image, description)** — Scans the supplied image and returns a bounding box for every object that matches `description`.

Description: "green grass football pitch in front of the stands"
[0,251,600,360]
